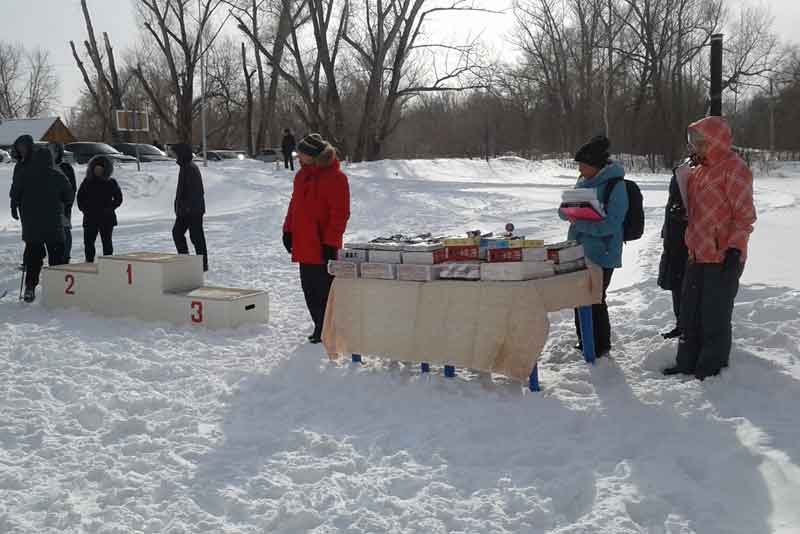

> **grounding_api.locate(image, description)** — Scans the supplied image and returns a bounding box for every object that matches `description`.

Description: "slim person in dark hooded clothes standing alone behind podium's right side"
[172,143,208,271]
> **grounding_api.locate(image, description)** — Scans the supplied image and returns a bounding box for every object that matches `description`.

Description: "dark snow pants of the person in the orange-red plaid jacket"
[677,262,744,378]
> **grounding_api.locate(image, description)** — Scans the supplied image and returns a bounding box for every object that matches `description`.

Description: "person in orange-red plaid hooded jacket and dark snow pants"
[663,117,756,380]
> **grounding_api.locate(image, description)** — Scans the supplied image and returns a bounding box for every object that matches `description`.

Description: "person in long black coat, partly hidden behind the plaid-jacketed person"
[658,158,694,339]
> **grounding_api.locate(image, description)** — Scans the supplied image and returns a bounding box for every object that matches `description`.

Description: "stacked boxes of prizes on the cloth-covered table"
[328,232,586,282]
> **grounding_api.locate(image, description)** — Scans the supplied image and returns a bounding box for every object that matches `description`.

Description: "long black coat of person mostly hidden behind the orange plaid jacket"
[658,162,689,290]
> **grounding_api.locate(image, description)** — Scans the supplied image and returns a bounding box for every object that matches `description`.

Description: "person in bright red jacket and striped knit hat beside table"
[283,134,350,343]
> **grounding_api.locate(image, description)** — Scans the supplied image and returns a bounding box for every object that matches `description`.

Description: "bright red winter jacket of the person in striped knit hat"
[283,159,350,265]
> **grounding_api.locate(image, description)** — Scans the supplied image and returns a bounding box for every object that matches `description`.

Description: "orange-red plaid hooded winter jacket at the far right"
[686,117,756,263]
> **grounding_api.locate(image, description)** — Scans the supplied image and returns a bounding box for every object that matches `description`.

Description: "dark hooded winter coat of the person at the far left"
[11,148,75,243]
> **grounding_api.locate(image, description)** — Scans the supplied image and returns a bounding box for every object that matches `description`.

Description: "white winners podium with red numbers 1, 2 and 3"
[42,252,269,328]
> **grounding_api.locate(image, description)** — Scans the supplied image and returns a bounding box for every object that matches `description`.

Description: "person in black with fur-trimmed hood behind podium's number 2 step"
[78,156,122,263]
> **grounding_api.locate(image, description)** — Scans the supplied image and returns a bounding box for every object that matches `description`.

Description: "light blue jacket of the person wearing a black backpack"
[559,162,628,269]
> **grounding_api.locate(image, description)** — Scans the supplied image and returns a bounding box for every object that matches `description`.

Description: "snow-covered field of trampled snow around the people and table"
[0,159,800,534]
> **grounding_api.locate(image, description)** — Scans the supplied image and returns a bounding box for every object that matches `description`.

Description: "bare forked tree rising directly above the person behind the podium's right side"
[133,0,228,143]
